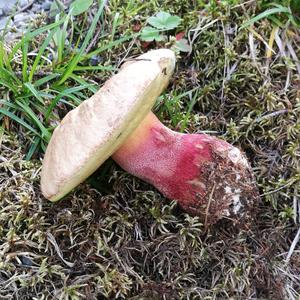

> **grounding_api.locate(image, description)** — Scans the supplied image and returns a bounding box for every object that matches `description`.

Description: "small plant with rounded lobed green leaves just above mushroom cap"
[140,11,191,52]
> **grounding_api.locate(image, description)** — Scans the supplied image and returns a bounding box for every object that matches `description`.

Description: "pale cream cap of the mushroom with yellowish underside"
[41,49,175,201]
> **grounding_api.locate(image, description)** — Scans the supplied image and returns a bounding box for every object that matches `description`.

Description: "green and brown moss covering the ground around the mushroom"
[0,0,300,299]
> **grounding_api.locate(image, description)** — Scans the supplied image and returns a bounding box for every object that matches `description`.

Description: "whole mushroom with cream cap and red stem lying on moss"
[41,49,257,225]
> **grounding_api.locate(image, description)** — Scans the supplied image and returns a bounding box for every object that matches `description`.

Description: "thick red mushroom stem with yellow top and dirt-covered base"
[112,113,257,225]
